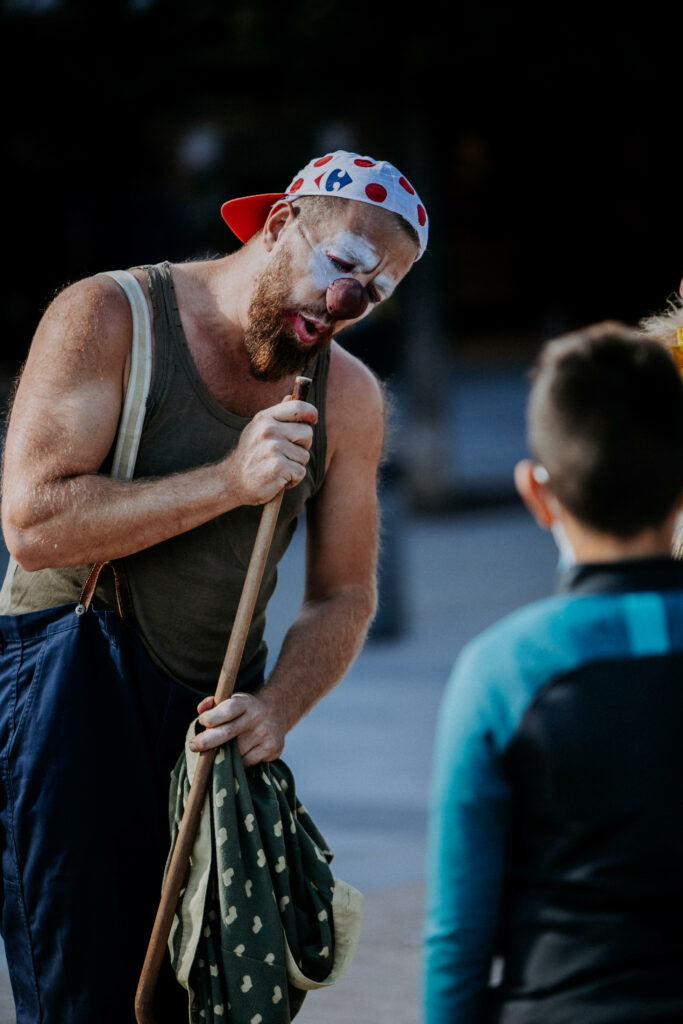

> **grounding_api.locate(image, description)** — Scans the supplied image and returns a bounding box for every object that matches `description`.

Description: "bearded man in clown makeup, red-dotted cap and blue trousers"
[0,152,428,1024]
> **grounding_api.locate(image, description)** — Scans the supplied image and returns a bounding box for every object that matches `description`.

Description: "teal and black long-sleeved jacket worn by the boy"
[424,559,683,1024]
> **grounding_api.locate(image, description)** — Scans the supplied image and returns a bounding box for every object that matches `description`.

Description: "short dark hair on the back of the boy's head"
[527,323,683,539]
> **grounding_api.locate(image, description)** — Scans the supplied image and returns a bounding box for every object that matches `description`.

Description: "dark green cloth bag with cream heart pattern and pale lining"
[164,723,362,1024]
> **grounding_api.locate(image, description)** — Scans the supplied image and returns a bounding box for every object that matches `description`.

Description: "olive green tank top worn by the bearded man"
[0,263,330,692]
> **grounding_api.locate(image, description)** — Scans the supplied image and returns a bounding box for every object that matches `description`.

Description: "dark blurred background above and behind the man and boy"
[0,0,683,506]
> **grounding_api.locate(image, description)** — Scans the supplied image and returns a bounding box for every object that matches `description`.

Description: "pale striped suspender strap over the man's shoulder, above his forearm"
[104,270,152,480]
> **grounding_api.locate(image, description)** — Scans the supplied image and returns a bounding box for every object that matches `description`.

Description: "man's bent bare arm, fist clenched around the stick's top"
[2,276,316,569]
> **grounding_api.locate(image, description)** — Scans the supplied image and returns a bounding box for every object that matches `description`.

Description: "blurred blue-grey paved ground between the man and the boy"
[0,350,556,1024]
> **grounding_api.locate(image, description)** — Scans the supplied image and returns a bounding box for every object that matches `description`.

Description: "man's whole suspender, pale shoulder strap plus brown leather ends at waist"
[76,270,152,622]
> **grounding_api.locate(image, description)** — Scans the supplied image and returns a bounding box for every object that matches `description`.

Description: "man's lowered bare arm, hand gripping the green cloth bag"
[191,348,384,765]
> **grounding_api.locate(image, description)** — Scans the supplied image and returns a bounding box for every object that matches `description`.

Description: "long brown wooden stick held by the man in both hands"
[135,377,311,1024]
